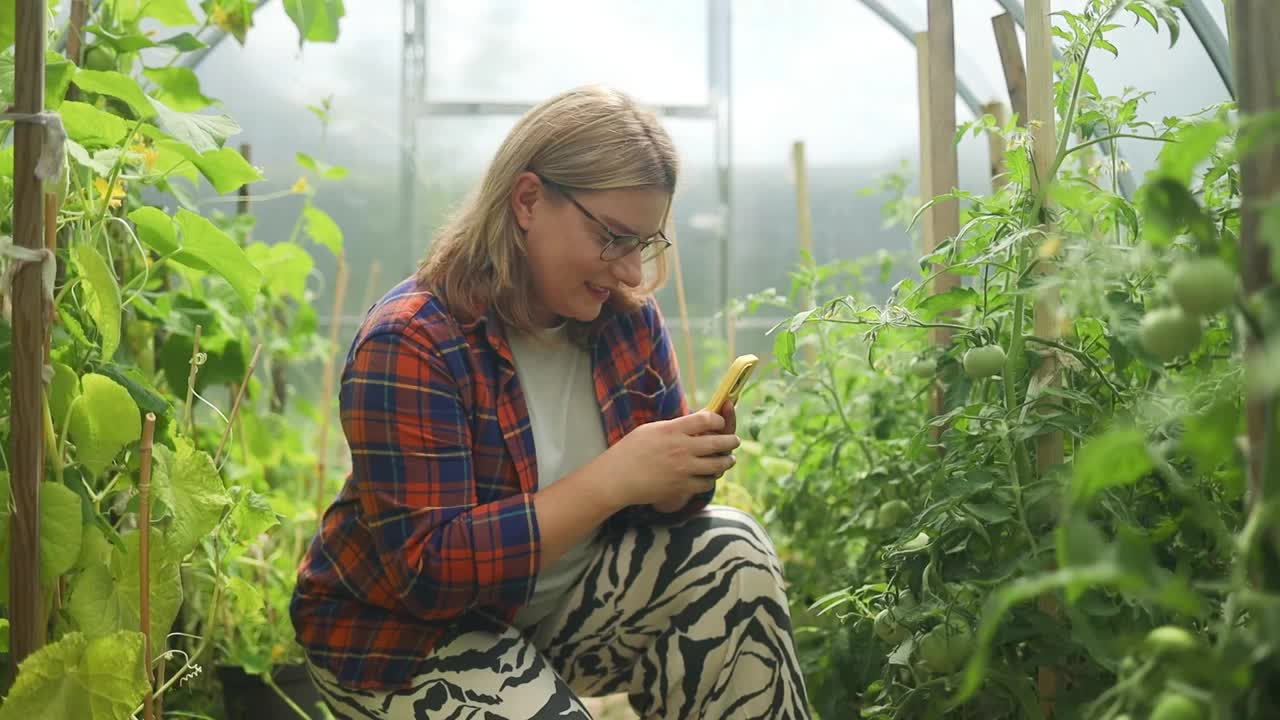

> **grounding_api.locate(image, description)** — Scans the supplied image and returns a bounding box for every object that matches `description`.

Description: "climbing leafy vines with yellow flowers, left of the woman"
[0,0,346,719]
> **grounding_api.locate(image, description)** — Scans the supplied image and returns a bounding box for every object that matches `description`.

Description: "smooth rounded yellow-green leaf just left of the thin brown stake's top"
[69,373,142,475]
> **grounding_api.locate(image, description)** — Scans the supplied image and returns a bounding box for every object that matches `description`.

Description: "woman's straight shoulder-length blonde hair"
[417,86,678,331]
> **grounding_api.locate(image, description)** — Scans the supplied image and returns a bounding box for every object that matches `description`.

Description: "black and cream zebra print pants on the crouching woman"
[308,506,809,720]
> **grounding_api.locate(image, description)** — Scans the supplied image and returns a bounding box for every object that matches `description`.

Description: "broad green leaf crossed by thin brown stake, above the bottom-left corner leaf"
[68,529,182,657]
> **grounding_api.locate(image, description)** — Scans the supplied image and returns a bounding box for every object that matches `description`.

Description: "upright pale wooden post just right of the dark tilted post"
[1027,0,1070,717]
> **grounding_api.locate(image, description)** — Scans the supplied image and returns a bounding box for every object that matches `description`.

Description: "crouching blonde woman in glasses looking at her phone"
[292,87,808,719]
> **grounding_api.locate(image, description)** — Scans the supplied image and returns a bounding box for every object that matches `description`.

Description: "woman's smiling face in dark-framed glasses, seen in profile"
[512,172,671,327]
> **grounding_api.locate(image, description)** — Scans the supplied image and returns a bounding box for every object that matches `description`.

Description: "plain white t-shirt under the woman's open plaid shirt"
[508,324,608,629]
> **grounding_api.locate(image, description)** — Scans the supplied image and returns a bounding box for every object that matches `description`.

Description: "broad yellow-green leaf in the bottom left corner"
[0,632,147,720]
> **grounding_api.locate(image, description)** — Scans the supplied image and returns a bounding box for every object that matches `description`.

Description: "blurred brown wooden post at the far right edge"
[1229,0,1280,532]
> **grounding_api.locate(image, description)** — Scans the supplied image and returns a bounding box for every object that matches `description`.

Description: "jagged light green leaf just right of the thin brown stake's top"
[152,437,230,557]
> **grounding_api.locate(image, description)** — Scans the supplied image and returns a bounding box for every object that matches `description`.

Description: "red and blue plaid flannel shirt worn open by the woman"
[291,278,714,691]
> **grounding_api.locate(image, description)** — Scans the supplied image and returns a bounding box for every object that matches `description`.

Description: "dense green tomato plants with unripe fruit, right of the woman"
[742,1,1280,720]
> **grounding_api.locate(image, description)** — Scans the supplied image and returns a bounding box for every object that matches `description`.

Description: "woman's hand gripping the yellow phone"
[598,405,740,512]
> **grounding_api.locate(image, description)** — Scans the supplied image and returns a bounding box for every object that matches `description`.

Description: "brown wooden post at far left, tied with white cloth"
[9,0,47,667]
